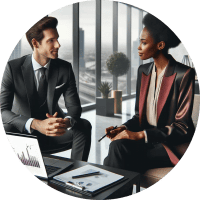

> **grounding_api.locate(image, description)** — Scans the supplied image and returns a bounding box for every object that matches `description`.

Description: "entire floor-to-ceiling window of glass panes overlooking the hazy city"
[6,0,192,108]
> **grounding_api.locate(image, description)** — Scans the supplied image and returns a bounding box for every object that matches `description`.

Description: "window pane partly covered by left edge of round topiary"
[101,1,113,88]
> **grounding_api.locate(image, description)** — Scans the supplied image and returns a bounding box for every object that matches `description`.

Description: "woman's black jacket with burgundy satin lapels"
[124,55,195,146]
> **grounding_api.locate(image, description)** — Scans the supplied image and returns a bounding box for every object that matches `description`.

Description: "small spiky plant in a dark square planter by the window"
[96,82,114,116]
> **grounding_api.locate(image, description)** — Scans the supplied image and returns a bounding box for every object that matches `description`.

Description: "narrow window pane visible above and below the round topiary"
[118,3,127,95]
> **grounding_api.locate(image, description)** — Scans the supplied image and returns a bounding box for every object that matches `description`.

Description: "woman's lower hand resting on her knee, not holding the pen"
[111,130,145,141]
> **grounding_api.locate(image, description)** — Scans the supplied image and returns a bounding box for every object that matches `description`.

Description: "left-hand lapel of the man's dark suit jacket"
[21,55,37,117]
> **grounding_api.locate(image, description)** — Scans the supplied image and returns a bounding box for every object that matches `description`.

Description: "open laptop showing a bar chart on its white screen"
[6,132,73,179]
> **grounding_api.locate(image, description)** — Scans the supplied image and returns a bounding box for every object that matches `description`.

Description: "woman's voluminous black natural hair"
[142,13,181,51]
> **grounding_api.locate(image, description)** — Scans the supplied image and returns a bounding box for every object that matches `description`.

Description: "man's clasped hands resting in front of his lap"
[31,115,68,136]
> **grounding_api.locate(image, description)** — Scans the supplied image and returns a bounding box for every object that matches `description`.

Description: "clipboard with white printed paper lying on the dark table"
[51,164,126,197]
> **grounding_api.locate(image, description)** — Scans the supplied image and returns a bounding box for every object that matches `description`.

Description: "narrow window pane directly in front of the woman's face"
[131,8,140,92]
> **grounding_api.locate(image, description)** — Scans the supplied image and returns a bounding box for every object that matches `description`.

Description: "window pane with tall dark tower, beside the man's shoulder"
[79,1,96,105]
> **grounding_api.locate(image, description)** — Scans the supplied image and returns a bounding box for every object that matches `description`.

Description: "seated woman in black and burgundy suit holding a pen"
[104,13,195,189]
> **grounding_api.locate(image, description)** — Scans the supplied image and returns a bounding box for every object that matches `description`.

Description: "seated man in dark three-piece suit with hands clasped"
[0,17,91,161]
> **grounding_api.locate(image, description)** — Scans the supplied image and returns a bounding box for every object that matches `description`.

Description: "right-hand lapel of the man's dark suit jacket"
[47,60,58,115]
